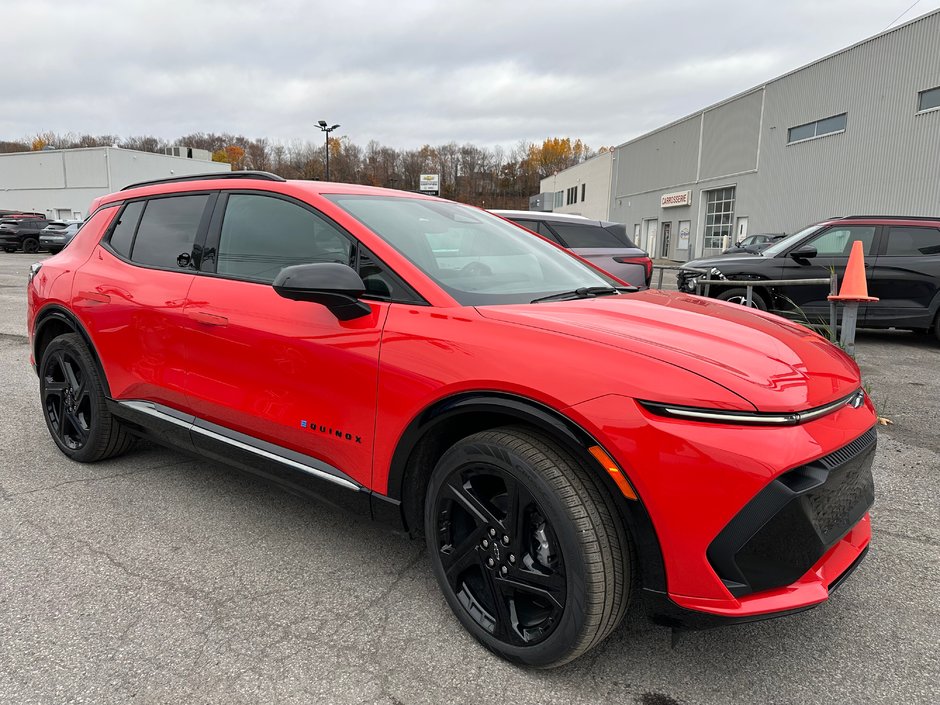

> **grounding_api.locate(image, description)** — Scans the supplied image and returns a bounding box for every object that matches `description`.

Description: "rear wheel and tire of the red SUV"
[39,333,134,463]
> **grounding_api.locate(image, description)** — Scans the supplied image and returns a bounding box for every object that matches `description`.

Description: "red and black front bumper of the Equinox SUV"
[569,395,875,621]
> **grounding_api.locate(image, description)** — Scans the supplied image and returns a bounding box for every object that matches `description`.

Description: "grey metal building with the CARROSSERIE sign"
[604,11,940,261]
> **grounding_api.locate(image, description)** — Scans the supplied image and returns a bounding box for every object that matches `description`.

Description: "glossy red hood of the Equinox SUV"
[478,290,860,412]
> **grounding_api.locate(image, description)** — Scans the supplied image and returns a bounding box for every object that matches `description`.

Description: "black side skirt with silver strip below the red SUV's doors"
[108,399,404,531]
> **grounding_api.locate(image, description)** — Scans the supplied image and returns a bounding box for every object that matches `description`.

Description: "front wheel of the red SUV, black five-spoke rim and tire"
[425,427,633,668]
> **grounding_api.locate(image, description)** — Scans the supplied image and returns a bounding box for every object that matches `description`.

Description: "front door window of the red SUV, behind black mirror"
[216,193,353,283]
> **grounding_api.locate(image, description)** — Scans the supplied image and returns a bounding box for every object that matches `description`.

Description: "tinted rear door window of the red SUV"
[131,194,209,269]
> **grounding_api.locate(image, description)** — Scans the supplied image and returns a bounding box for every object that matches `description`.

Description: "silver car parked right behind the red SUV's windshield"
[490,210,653,288]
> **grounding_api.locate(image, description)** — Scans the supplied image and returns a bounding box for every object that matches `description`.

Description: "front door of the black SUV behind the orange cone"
[774,223,878,323]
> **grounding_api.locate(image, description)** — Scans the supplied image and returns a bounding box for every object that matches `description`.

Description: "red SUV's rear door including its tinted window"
[72,192,215,411]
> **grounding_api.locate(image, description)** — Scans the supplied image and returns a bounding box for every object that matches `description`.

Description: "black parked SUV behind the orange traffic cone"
[678,216,940,338]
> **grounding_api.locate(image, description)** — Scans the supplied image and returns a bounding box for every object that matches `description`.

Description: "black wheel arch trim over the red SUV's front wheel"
[387,391,666,590]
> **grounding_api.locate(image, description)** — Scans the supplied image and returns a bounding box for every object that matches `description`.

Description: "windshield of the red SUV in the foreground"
[327,194,621,306]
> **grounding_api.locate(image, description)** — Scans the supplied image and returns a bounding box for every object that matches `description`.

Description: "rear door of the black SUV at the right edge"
[866,225,940,328]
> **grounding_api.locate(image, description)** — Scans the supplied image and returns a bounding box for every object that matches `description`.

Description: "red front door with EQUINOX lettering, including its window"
[185,192,388,485]
